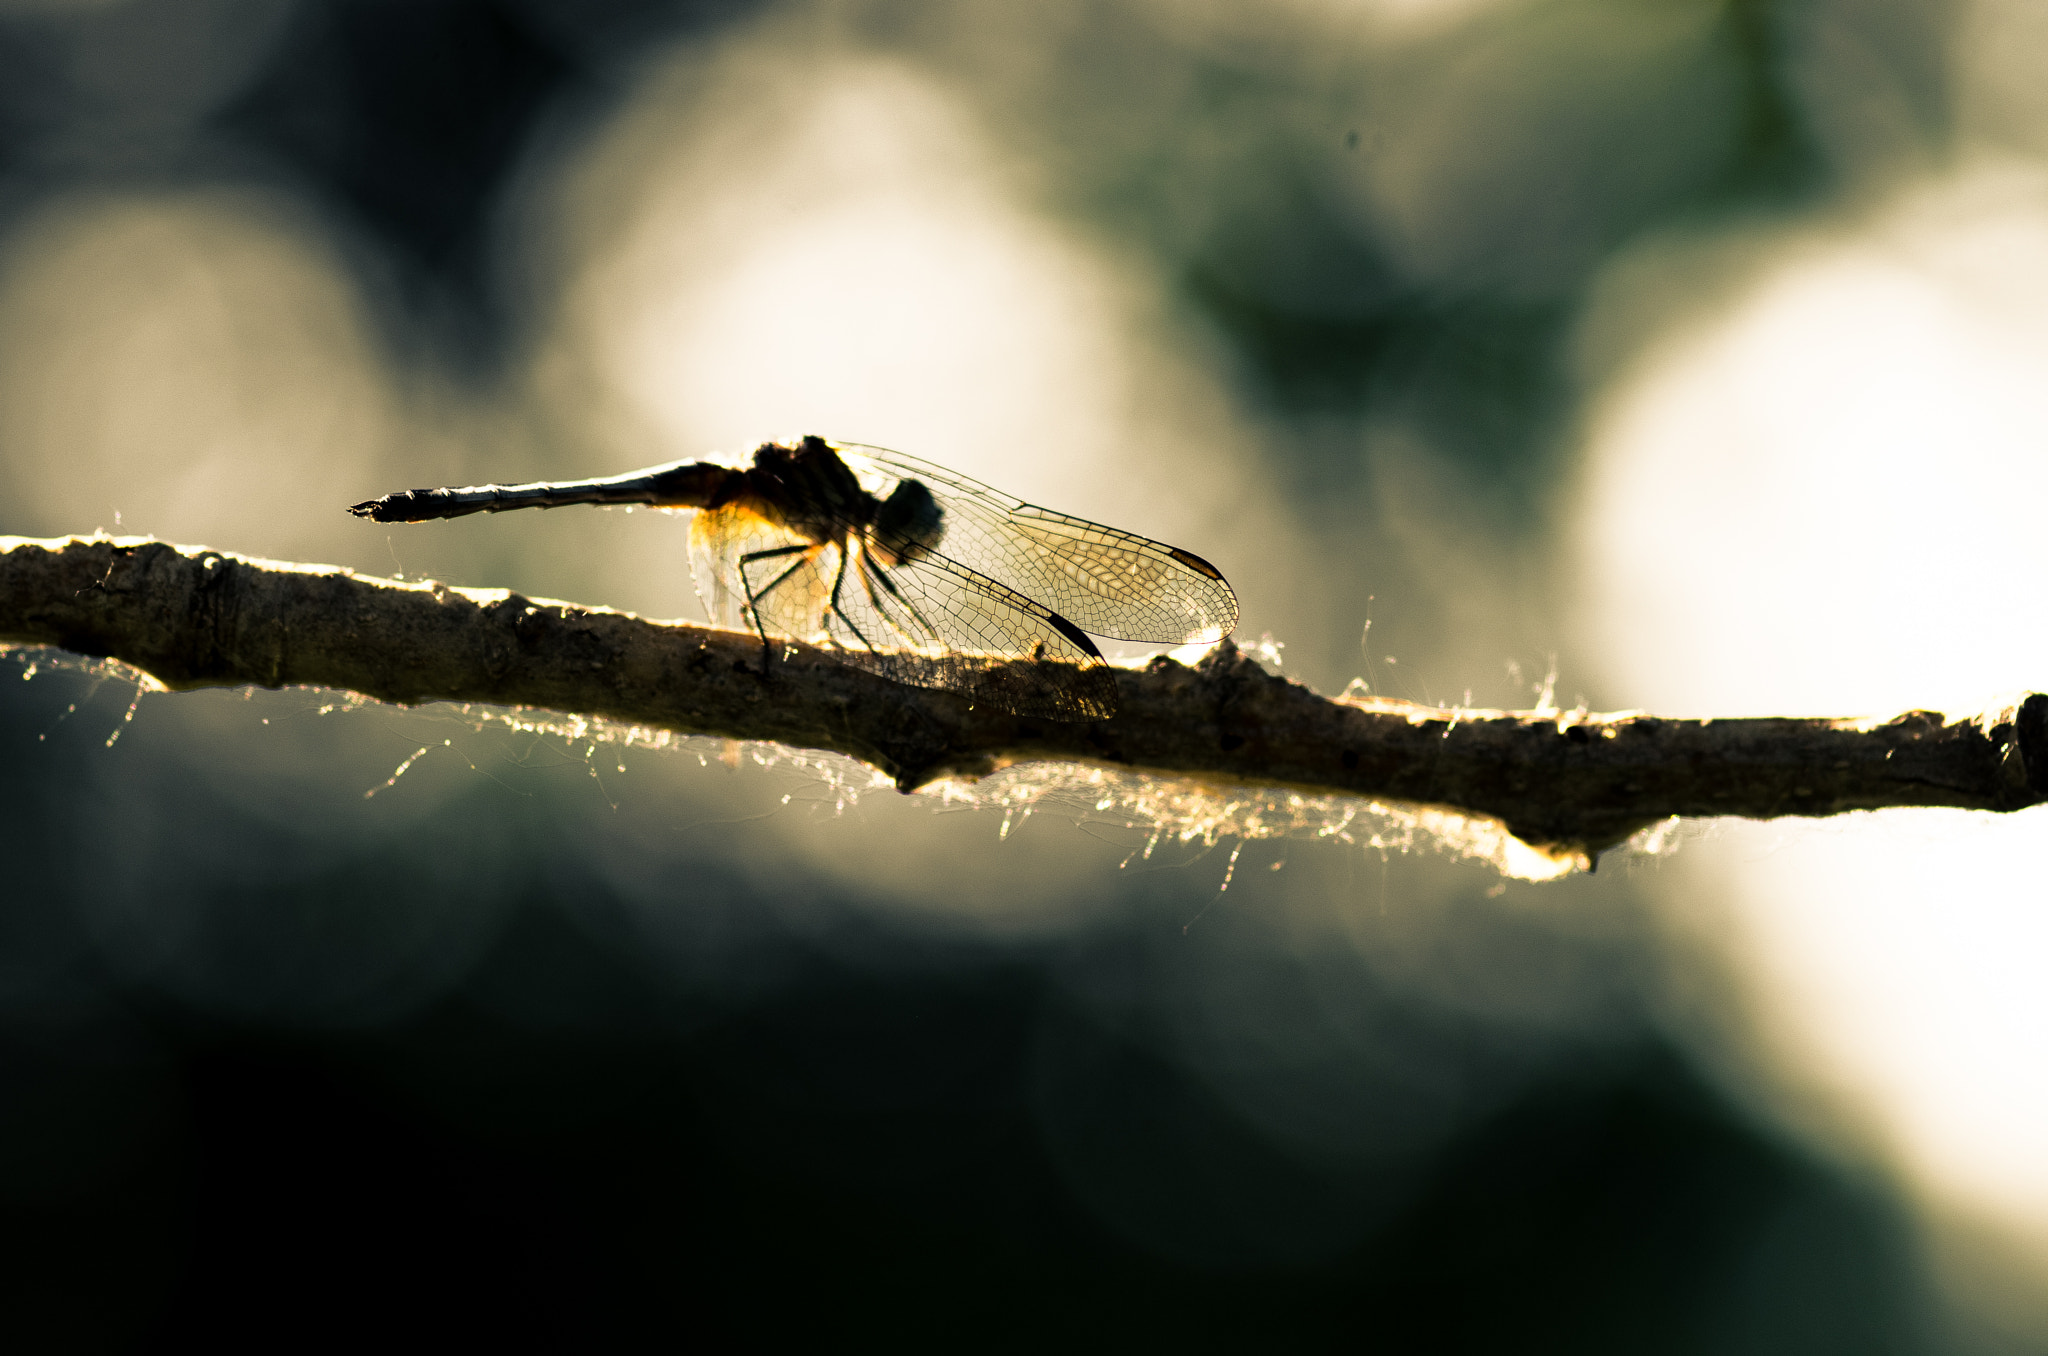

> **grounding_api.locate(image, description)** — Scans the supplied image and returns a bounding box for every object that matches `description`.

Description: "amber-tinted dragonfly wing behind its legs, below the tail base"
[690,504,840,641]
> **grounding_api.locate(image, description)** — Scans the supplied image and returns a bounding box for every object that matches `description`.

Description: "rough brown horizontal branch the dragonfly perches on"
[12,537,2048,860]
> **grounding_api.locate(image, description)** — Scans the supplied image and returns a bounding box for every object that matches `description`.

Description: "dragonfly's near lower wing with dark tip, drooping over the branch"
[829,549,1116,721]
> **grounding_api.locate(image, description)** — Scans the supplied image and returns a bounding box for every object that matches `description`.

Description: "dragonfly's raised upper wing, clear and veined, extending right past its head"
[834,442,1237,645]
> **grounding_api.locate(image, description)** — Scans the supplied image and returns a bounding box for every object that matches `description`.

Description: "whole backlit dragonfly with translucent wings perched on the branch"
[348,436,1237,721]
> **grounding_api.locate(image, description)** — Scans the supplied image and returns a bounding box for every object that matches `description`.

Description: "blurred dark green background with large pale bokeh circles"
[0,0,2048,1354]
